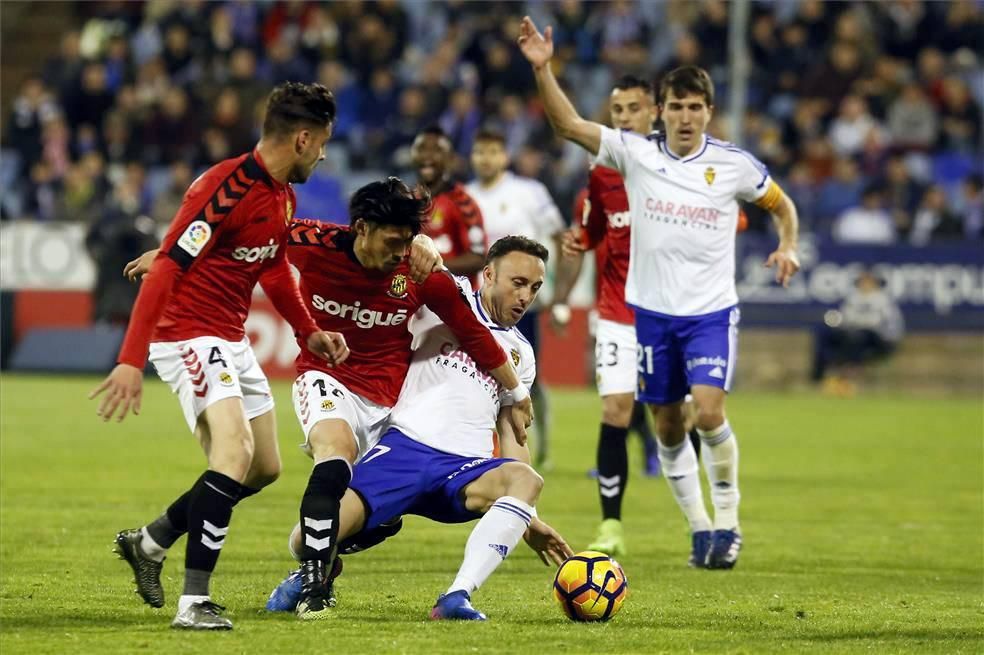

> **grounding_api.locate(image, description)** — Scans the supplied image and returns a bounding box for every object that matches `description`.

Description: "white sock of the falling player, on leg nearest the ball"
[447,496,536,596]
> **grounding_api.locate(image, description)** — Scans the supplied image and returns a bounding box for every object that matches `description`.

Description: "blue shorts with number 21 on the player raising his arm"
[636,306,741,405]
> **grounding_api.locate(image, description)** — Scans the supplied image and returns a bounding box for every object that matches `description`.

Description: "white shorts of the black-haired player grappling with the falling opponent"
[292,371,392,457]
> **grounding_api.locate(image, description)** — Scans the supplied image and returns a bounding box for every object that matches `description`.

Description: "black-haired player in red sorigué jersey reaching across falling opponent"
[288,178,532,620]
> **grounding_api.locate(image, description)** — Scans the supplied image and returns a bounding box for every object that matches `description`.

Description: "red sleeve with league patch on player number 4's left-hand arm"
[117,156,253,368]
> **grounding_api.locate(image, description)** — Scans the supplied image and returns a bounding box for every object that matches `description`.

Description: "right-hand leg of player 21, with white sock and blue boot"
[692,384,741,569]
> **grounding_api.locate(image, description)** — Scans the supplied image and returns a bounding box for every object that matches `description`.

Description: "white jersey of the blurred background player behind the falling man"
[465,171,564,246]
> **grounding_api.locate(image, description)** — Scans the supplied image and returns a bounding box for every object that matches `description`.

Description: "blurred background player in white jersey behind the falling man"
[465,129,565,469]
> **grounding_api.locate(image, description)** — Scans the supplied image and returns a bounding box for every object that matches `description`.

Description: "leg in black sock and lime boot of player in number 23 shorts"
[588,393,635,557]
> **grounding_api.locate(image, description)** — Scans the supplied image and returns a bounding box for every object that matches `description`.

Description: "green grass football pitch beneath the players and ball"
[0,375,984,655]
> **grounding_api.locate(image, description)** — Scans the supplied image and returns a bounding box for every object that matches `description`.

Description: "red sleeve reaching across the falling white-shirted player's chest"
[420,271,506,371]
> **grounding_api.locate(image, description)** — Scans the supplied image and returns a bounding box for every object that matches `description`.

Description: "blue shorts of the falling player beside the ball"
[349,428,515,530]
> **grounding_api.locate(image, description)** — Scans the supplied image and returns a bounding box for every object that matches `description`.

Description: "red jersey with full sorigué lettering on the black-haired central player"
[287,220,506,407]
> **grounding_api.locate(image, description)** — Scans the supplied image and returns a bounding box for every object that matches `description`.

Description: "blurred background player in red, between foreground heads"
[410,127,488,284]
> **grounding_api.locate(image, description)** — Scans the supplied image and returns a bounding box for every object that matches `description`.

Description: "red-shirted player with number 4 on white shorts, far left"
[90,82,348,630]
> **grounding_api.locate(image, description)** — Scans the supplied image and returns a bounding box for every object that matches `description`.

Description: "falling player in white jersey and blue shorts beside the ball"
[267,236,573,621]
